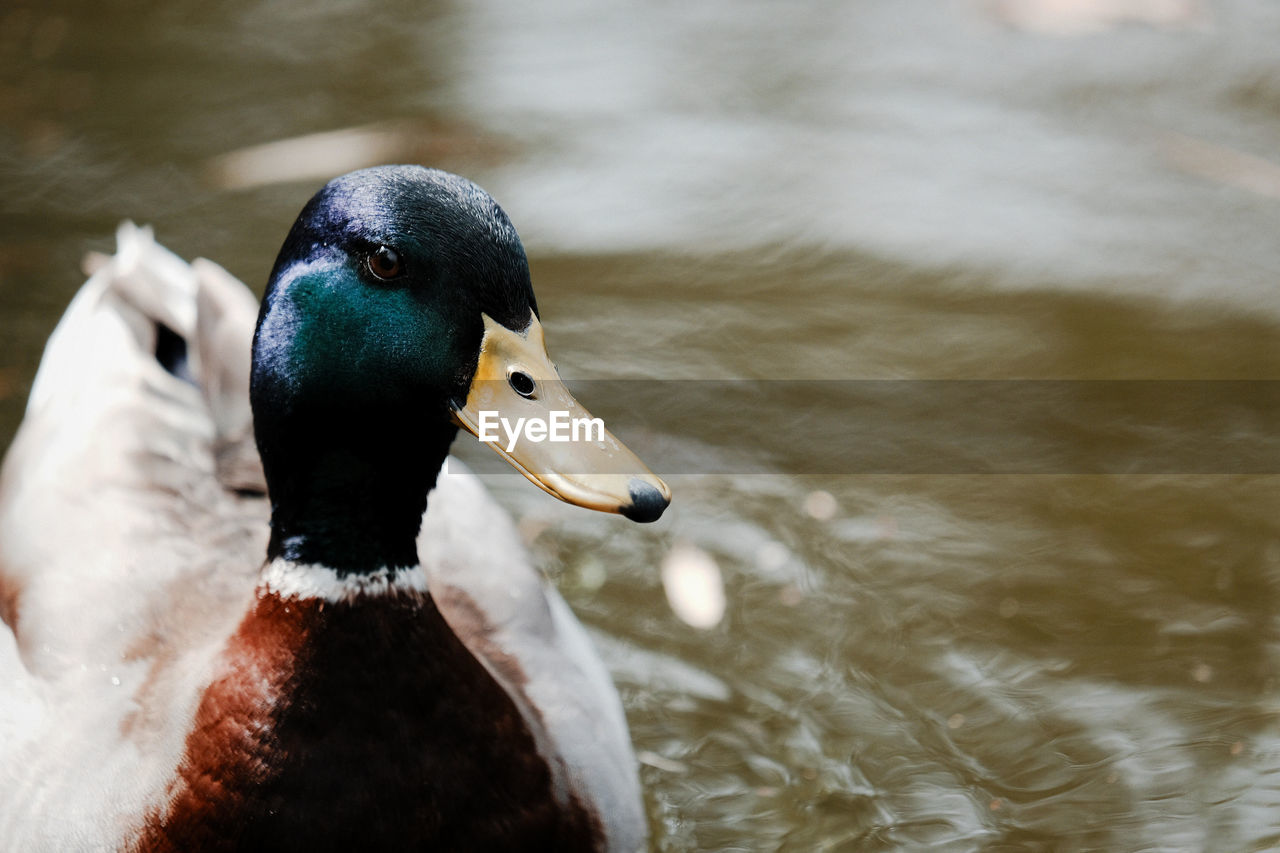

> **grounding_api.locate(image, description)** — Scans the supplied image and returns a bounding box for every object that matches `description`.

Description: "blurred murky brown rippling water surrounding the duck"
[0,0,1280,852]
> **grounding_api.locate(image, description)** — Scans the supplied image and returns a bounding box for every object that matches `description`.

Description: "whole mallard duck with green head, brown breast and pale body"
[0,167,669,850]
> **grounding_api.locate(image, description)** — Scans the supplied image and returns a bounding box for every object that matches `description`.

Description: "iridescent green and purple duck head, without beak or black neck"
[253,167,536,419]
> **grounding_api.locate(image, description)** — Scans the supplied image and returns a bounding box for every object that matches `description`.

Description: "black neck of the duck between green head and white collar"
[260,411,457,576]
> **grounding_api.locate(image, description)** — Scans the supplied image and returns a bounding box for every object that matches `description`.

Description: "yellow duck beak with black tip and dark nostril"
[453,314,671,521]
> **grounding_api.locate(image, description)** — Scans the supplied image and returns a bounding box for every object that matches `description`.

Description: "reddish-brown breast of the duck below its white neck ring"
[136,594,602,850]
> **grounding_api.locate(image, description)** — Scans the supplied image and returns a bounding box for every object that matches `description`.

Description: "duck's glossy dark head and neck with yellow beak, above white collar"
[251,167,671,571]
